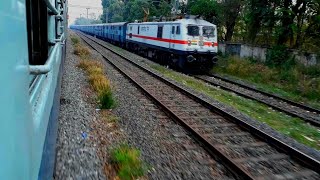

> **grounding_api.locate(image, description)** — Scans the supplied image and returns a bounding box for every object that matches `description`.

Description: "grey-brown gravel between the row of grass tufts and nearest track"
[75,32,233,179]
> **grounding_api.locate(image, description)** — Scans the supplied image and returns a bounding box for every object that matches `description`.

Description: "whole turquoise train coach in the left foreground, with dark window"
[0,0,67,180]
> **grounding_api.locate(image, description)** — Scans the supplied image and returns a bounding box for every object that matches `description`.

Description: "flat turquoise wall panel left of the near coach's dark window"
[0,0,33,180]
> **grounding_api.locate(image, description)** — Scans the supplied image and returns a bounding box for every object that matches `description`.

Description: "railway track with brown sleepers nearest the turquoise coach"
[75,33,320,179]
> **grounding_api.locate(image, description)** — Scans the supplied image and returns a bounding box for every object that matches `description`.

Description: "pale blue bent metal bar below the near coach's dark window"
[29,34,64,75]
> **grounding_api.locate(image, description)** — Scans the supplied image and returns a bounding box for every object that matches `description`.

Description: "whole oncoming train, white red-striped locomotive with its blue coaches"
[71,16,218,72]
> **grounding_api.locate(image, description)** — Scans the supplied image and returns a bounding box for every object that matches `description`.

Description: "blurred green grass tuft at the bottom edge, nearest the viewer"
[111,144,145,180]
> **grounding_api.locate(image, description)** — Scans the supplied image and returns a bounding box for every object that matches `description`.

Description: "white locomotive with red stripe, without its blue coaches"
[126,19,218,70]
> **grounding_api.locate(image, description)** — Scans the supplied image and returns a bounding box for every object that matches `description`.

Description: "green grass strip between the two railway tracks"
[150,65,320,150]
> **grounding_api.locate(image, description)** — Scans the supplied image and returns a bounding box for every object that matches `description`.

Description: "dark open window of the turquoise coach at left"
[26,0,49,65]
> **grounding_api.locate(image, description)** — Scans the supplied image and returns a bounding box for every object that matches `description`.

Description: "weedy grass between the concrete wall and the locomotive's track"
[213,56,320,109]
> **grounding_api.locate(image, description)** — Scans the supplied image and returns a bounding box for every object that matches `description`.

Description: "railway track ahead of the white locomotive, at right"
[194,75,320,127]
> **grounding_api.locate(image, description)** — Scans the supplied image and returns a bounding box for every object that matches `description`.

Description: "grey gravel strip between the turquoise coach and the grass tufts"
[54,33,106,179]
